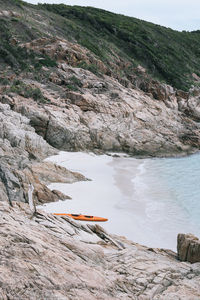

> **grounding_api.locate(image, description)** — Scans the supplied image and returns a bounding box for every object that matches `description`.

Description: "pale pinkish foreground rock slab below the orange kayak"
[0,203,200,300]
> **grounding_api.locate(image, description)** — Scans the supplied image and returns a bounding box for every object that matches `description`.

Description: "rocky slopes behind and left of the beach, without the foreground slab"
[0,32,200,210]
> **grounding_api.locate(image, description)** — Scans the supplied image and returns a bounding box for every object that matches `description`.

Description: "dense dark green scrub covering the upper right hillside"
[40,4,200,90]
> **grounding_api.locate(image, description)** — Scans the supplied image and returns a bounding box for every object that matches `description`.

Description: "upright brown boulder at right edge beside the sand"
[177,234,200,263]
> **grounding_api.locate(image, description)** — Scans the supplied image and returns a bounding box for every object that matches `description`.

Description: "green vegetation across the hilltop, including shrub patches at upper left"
[0,0,200,90]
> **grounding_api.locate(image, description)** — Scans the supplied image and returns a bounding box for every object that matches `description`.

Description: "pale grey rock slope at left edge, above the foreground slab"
[0,104,51,202]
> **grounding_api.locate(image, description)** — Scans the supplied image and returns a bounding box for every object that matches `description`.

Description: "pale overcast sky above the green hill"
[25,0,200,31]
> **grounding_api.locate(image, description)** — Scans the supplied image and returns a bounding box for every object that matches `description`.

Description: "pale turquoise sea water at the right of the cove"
[145,154,200,237]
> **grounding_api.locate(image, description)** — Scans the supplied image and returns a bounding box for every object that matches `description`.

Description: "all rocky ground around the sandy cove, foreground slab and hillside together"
[0,0,200,300]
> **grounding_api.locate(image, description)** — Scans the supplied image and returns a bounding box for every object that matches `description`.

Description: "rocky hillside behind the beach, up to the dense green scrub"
[0,6,200,156]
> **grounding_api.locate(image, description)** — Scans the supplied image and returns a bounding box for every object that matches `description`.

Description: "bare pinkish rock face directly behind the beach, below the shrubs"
[1,63,200,156]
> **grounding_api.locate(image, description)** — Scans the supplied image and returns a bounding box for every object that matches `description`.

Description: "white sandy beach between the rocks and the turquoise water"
[39,152,200,250]
